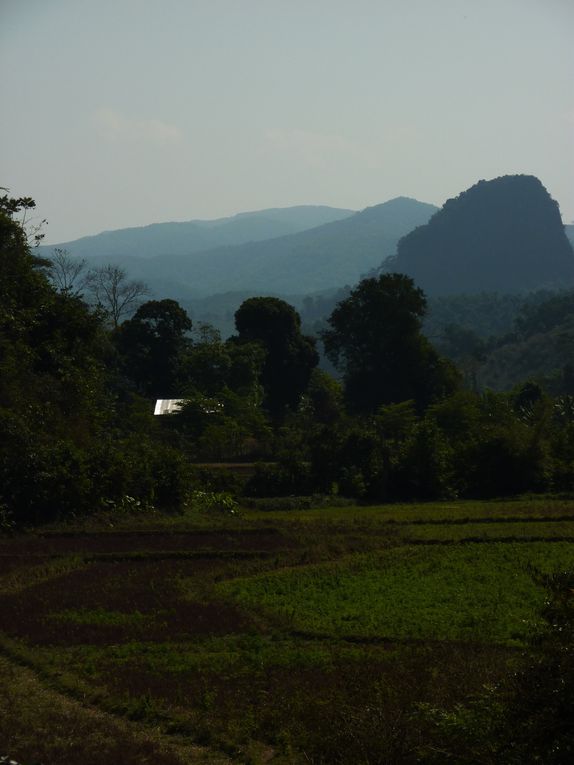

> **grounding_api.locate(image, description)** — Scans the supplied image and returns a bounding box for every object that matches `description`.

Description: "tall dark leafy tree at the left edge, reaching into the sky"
[0,200,107,522]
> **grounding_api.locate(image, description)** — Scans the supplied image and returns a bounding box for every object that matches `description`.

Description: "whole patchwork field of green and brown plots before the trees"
[0,498,574,765]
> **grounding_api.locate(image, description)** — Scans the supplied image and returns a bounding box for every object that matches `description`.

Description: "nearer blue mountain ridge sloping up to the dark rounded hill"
[46,197,437,299]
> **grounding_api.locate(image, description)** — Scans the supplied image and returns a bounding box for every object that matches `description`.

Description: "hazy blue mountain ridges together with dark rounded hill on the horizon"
[42,175,574,314]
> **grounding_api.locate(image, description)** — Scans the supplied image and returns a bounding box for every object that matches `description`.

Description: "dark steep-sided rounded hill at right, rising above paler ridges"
[383,175,574,295]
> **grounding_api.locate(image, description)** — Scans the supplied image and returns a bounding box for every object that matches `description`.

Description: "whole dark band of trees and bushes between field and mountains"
[0,196,574,525]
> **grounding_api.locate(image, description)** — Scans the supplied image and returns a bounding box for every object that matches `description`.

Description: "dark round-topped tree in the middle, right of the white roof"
[235,297,319,420]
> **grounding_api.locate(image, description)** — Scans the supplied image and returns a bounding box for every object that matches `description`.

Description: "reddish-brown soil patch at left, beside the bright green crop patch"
[0,560,252,645]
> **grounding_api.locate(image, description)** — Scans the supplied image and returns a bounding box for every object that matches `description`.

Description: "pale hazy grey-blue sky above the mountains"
[0,0,574,242]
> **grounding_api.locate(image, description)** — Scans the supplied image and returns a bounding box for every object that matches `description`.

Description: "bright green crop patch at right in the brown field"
[218,542,574,644]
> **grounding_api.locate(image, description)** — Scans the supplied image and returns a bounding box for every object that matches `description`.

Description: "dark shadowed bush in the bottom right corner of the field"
[419,571,574,765]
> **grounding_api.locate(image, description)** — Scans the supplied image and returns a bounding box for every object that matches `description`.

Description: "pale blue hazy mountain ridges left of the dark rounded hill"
[44,197,437,299]
